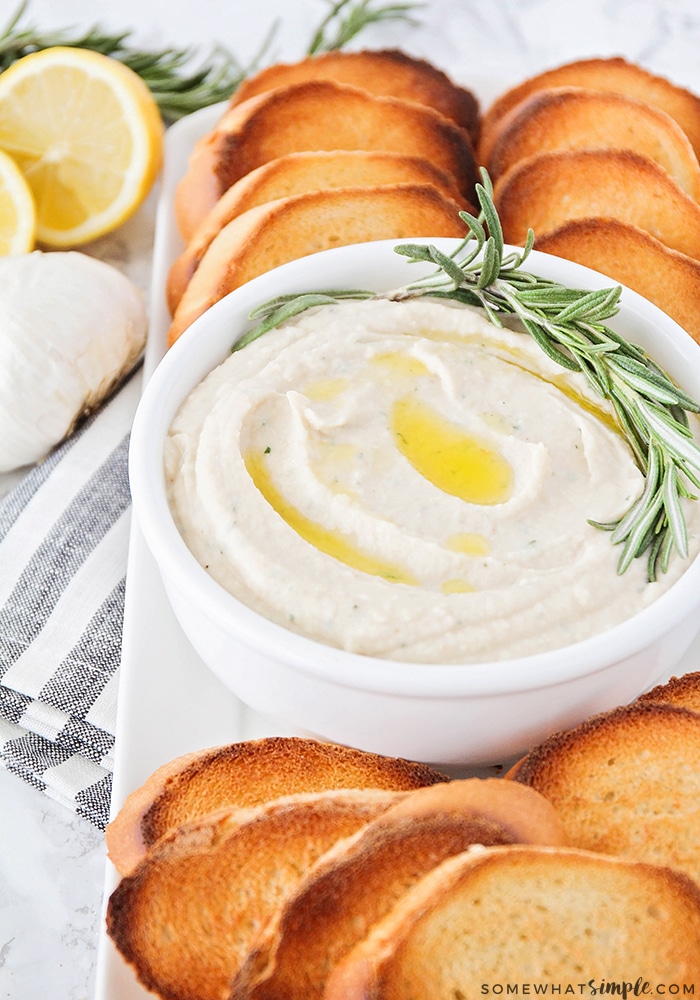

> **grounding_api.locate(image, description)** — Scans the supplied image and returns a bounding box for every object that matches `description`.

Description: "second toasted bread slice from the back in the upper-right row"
[486,87,700,200]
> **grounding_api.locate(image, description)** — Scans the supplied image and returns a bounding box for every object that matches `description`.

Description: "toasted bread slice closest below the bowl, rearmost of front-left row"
[105,736,447,875]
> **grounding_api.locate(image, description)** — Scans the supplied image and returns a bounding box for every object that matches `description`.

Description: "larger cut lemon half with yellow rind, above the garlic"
[0,46,164,247]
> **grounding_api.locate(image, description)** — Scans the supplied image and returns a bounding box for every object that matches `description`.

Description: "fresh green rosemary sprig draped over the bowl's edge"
[239,169,700,580]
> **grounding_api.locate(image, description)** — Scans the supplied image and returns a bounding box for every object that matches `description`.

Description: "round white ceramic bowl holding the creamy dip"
[130,239,700,765]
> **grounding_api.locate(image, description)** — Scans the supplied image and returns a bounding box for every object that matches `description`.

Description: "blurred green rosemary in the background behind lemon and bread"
[0,0,422,124]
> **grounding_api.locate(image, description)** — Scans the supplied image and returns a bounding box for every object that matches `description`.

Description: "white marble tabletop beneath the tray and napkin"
[0,0,700,1000]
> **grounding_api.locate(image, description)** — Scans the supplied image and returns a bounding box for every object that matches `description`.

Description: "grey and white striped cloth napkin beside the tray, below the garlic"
[0,370,141,829]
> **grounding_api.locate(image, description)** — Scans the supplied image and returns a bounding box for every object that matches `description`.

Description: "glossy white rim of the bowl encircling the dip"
[129,237,700,698]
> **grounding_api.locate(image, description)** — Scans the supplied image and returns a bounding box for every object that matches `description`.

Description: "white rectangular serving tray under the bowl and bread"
[95,95,700,1000]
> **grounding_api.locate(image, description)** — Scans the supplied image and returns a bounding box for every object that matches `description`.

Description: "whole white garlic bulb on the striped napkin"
[0,250,147,472]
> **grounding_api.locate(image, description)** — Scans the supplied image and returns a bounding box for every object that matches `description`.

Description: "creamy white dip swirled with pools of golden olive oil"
[165,299,700,662]
